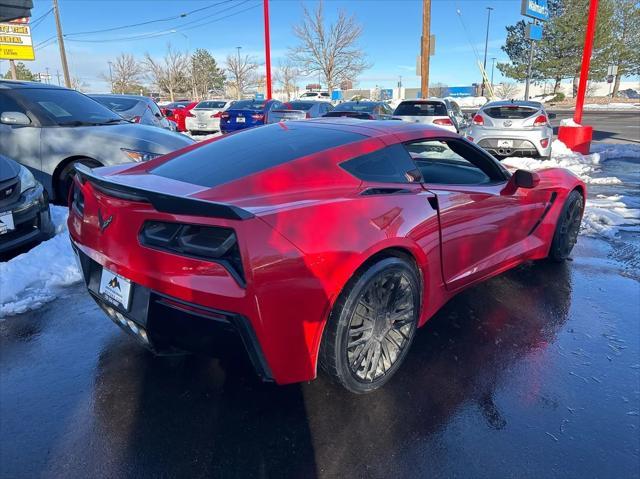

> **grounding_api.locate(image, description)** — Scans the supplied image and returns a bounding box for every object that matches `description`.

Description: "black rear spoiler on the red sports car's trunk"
[75,163,254,220]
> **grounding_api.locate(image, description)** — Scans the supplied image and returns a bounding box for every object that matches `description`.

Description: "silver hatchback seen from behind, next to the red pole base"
[465,100,555,159]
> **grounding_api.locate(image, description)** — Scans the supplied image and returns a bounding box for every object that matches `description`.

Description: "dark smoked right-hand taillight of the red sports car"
[139,221,244,285]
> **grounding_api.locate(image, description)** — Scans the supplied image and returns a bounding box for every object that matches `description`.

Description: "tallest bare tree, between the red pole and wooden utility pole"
[290,2,370,92]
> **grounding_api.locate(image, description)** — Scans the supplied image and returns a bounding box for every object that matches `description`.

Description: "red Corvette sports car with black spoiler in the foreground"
[69,119,586,393]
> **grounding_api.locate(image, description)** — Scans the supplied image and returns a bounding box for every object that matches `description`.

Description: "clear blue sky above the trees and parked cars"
[0,0,521,91]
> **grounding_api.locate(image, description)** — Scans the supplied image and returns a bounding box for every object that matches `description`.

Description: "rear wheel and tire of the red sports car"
[319,257,421,394]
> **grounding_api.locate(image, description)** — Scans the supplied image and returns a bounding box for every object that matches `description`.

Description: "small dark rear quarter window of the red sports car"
[340,145,416,183]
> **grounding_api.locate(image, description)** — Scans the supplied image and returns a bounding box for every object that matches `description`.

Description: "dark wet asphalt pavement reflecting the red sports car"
[0,237,640,478]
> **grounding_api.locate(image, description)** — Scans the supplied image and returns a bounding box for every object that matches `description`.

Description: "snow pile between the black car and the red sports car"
[0,206,82,319]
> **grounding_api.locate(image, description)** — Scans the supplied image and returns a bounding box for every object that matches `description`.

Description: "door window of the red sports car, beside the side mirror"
[405,140,496,185]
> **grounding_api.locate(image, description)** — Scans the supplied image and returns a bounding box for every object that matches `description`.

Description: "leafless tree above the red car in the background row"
[144,44,190,101]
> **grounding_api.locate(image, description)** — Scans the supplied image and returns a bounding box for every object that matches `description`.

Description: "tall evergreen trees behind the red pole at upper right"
[496,0,640,97]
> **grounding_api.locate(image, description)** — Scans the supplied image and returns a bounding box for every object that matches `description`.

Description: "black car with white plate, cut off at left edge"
[0,155,54,253]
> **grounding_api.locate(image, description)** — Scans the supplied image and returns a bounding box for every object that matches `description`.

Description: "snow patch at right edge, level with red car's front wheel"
[582,195,640,238]
